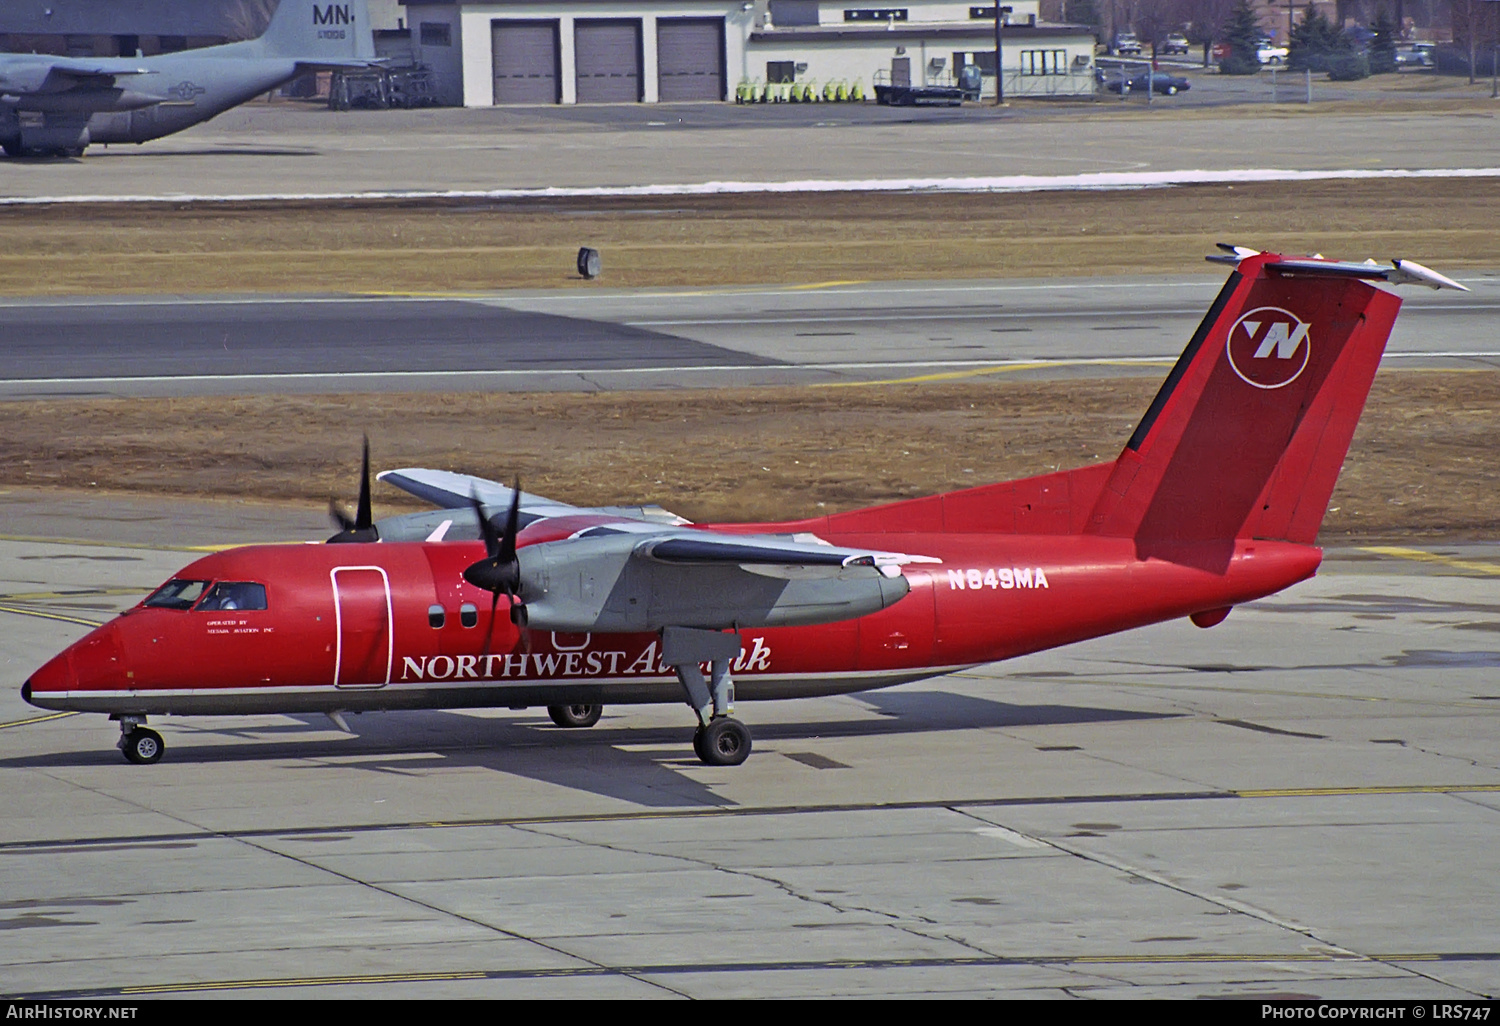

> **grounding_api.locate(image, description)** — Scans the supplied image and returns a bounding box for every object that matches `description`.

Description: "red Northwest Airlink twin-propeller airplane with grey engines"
[21,248,1463,765]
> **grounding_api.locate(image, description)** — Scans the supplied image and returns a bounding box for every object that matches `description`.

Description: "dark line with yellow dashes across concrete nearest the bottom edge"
[11,951,1500,1001]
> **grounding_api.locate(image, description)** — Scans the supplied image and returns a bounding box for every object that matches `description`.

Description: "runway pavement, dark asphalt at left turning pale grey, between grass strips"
[0,272,1500,399]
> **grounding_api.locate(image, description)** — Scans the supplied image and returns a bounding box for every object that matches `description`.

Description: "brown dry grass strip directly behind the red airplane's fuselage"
[0,371,1500,540]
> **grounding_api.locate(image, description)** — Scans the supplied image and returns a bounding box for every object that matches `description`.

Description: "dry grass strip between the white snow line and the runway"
[0,179,1500,296]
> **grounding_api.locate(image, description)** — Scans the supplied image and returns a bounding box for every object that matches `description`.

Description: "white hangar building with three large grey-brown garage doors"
[404,0,1094,107]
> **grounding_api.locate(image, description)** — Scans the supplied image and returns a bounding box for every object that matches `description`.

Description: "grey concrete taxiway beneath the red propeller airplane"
[0,494,1500,999]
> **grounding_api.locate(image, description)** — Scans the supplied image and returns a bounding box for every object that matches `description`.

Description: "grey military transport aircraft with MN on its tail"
[0,0,378,158]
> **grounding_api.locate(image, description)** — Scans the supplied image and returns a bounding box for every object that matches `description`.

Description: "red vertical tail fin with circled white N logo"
[1086,254,1398,554]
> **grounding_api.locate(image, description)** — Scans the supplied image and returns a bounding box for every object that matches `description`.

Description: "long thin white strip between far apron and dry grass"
[0,168,1500,206]
